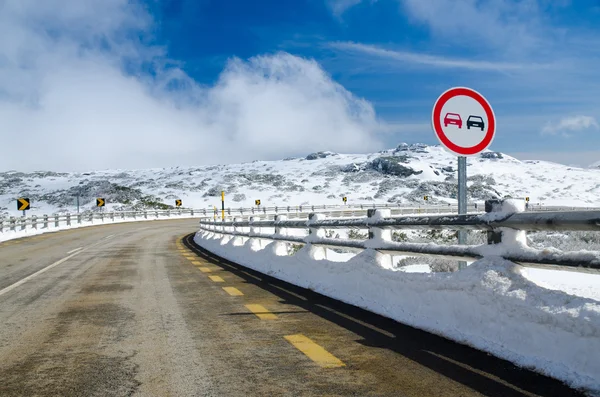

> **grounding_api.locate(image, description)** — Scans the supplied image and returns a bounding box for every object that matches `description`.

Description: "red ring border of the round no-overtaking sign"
[431,87,496,156]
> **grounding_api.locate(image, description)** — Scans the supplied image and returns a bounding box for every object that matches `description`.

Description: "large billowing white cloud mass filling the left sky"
[0,0,383,170]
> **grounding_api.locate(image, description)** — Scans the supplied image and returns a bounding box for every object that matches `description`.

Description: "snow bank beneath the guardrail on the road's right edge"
[195,232,600,391]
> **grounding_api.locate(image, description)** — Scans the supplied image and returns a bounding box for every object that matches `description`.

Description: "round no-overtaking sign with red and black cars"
[431,87,496,156]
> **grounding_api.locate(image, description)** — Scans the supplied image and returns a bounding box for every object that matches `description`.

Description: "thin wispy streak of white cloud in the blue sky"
[329,42,546,71]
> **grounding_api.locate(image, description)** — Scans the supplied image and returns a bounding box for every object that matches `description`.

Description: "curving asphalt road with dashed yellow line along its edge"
[0,220,578,397]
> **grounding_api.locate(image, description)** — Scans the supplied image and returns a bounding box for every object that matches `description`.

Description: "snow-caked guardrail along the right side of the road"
[200,200,600,271]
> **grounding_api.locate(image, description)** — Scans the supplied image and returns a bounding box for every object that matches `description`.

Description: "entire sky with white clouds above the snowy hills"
[0,0,600,171]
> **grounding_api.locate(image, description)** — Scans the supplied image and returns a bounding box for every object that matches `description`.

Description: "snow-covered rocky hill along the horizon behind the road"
[0,143,600,215]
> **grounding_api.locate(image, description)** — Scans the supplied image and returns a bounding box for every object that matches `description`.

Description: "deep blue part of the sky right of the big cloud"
[150,0,600,156]
